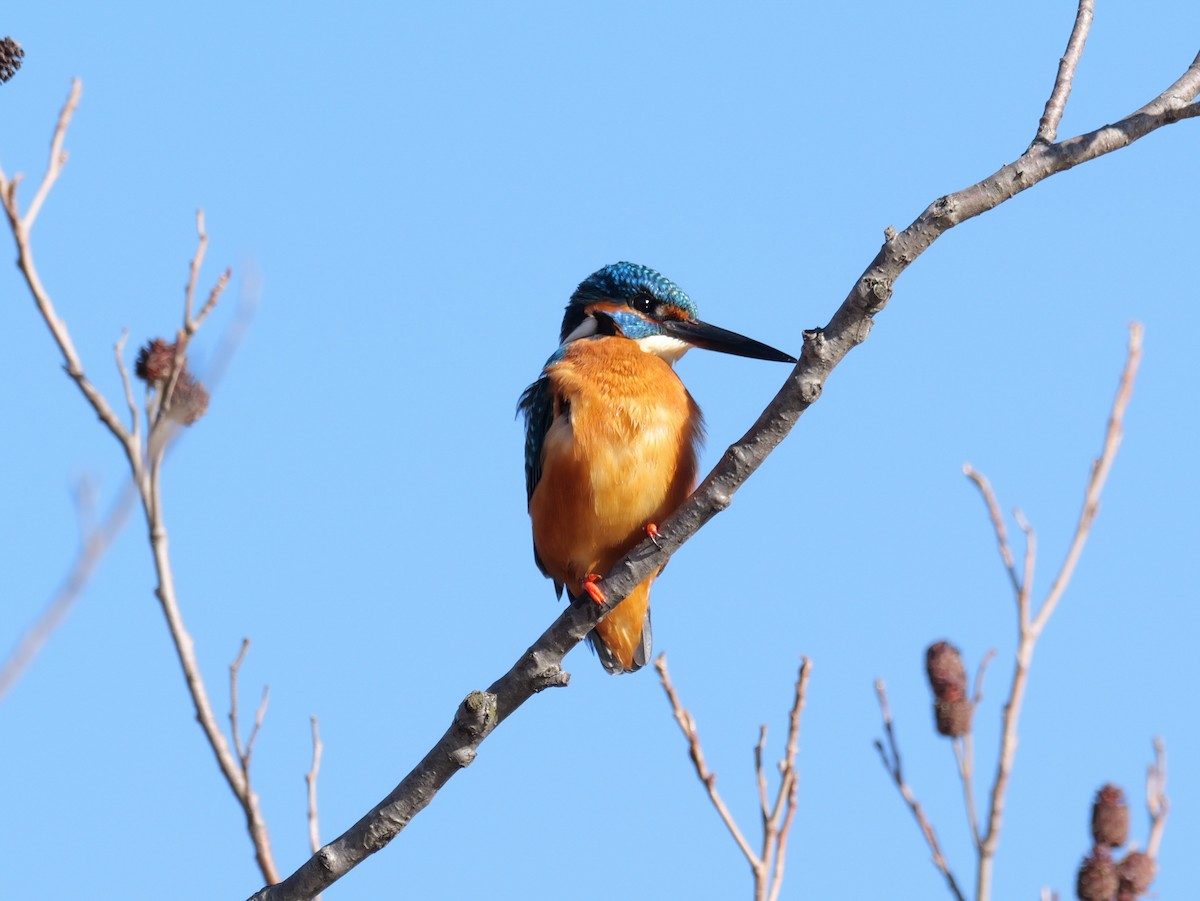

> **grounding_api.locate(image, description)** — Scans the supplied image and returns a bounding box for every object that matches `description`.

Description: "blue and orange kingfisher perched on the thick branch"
[517,263,796,673]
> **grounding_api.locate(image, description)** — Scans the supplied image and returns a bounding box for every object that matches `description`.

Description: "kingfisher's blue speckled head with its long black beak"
[559,263,796,364]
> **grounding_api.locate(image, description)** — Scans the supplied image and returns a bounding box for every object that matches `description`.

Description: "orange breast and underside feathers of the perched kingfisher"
[529,337,701,668]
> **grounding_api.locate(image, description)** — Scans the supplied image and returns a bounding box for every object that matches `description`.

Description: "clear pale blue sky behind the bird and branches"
[0,0,1200,900]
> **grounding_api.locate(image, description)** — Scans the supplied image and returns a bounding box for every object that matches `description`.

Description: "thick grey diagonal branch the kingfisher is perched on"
[246,28,1200,901]
